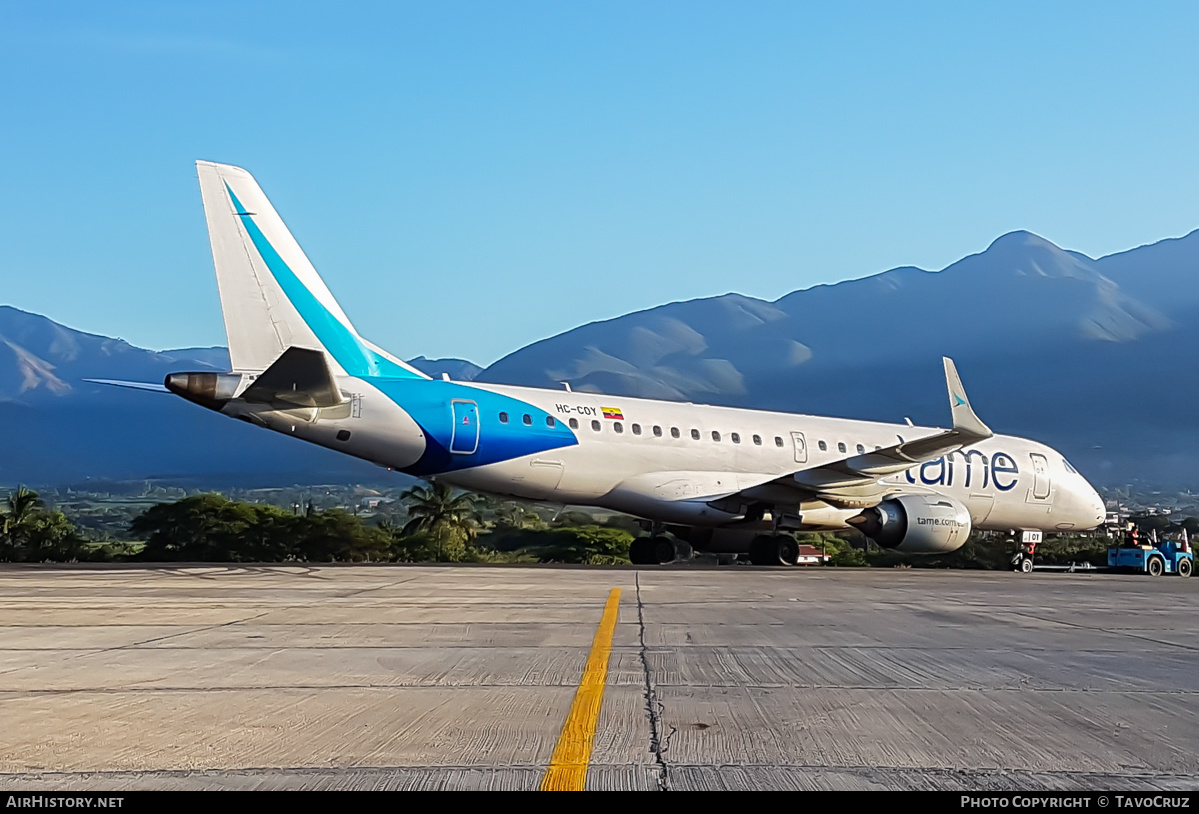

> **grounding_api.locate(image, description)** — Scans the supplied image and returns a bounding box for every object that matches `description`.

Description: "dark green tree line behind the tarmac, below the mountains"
[0,483,1160,569]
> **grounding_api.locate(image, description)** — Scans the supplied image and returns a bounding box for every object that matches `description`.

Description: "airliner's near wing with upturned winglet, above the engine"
[725,357,994,505]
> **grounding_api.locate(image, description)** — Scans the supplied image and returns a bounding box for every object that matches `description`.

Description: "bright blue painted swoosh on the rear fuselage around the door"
[368,379,579,476]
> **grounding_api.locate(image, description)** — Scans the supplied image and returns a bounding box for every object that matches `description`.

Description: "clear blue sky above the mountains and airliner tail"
[0,0,1199,364]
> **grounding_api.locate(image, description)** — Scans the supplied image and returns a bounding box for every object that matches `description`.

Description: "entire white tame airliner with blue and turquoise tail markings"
[165,162,1104,565]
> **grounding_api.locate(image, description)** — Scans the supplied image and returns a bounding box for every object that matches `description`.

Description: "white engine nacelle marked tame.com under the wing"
[849,495,970,554]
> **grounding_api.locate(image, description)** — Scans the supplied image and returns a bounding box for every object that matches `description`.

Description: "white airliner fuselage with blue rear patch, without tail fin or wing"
[215,378,1104,541]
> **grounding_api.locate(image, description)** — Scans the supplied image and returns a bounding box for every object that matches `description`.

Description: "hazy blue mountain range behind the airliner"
[0,226,1199,488]
